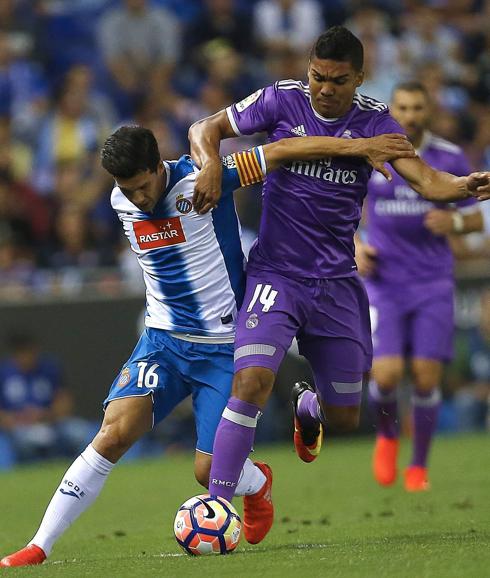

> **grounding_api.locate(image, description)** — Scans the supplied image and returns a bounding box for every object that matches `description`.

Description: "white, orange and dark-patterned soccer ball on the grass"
[174,494,242,556]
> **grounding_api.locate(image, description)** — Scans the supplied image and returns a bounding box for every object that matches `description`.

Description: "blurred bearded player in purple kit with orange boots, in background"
[356,82,483,491]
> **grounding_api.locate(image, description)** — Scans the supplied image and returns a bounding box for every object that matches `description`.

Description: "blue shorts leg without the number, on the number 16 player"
[190,344,233,455]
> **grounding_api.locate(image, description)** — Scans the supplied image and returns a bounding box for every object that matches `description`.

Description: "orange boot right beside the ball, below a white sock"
[243,462,274,544]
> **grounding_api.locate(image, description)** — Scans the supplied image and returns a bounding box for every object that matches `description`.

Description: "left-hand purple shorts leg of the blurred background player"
[367,284,409,359]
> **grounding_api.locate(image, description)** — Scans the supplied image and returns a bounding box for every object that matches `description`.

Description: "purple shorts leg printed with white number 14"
[235,273,303,374]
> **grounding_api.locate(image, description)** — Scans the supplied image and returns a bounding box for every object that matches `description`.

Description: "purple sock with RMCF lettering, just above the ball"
[209,397,261,502]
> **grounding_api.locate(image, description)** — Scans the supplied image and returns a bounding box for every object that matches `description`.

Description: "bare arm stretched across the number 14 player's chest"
[263,134,417,174]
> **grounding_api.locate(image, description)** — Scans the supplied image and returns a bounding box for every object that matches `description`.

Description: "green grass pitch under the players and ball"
[0,435,490,578]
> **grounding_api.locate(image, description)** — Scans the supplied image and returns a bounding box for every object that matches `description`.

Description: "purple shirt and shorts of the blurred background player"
[365,132,477,361]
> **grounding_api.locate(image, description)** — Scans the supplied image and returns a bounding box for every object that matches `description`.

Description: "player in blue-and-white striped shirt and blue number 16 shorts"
[0,127,409,567]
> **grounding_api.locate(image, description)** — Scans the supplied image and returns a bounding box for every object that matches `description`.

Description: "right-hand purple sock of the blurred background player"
[411,389,441,468]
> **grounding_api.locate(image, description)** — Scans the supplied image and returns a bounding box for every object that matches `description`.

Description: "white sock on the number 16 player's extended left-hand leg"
[29,445,114,556]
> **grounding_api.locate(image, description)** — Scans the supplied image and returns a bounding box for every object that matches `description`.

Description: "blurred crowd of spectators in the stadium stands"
[0,0,490,446]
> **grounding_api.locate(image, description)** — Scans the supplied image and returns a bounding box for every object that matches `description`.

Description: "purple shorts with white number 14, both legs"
[235,271,372,406]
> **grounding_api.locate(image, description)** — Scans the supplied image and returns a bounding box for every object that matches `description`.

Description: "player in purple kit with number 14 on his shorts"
[189,26,490,541]
